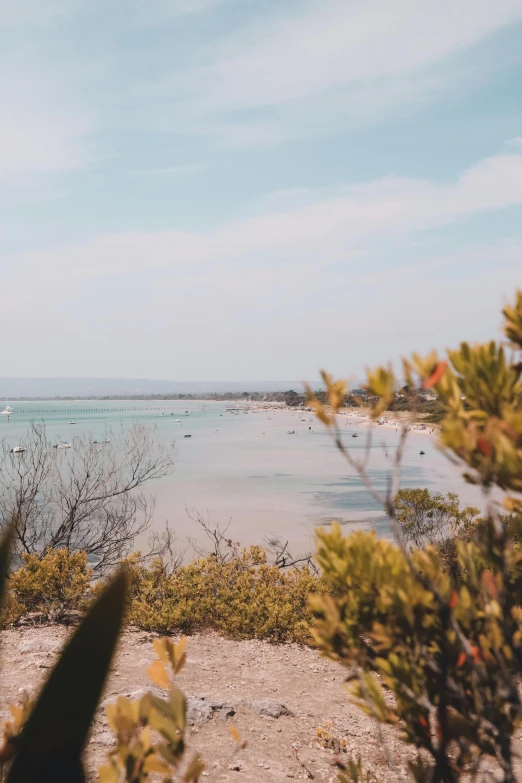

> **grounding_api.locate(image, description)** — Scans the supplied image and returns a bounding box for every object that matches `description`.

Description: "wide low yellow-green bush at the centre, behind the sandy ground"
[128,547,322,642]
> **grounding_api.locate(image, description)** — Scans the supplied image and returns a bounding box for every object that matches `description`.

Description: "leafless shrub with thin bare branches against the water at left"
[0,423,174,572]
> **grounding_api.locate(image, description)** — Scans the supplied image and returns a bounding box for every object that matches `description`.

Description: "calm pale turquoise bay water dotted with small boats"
[0,401,481,550]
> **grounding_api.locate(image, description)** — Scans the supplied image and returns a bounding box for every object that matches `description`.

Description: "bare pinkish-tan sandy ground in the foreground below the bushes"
[0,626,405,783]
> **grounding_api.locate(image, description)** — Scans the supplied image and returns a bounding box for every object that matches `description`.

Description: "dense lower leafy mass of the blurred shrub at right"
[312,523,522,774]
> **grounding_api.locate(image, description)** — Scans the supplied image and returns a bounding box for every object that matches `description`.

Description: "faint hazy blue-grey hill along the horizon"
[0,378,303,401]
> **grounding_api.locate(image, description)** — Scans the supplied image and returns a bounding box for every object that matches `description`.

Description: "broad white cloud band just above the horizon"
[3,237,522,380]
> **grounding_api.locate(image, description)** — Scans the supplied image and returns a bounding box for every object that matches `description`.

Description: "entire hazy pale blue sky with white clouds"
[0,0,522,380]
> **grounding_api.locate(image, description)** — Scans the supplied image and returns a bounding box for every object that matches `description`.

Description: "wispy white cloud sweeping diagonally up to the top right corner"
[136,0,522,147]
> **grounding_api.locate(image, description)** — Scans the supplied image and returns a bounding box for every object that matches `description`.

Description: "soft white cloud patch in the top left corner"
[0,0,96,181]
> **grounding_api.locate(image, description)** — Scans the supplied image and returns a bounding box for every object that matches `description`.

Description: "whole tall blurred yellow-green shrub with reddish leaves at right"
[310,291,522,783]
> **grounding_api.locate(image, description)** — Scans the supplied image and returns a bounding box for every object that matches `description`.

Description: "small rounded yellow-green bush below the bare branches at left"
[2,549,91,624]
